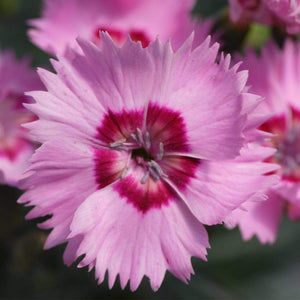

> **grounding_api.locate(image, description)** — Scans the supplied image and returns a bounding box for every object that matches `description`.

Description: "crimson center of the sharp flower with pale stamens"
[95,103,200,213]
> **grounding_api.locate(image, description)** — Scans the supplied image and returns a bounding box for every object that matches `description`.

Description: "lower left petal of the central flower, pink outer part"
[18,138,126,248]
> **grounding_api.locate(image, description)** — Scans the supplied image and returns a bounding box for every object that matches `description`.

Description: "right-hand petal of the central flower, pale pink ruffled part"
[181,145,279,225]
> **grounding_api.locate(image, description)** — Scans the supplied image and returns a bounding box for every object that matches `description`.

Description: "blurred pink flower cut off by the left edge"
[0,51,41,185]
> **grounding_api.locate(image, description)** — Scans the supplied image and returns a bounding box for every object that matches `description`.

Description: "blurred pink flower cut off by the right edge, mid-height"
[228,40,300,243]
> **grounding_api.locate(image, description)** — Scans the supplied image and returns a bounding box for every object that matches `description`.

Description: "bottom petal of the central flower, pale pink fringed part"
[69,187,209,290]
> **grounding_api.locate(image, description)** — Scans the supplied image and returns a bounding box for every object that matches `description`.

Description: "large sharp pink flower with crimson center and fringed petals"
[19,34,275,290]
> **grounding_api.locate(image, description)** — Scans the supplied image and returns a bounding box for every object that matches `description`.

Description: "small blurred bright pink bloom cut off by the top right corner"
[264,0,300,34]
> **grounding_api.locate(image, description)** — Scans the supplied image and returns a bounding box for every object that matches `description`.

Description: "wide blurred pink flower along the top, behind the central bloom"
[29,0,212,55]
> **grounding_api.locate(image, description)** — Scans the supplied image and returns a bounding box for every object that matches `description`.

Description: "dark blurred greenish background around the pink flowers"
[0,0,300,299]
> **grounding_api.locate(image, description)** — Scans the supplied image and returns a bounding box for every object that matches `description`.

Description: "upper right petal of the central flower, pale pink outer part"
[147,38,247,159]
